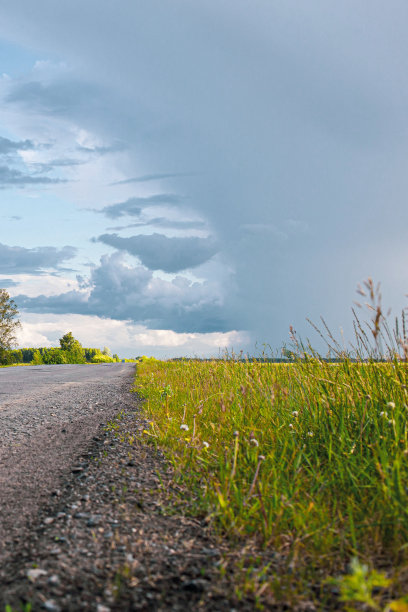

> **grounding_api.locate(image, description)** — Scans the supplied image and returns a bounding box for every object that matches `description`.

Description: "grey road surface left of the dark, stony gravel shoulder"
[0,363,135,565]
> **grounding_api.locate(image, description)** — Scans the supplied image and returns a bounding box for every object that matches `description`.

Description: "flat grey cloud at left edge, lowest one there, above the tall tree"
[0,243,77,274]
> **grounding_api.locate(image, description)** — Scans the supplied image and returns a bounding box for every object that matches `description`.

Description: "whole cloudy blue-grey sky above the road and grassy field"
[0,0,408,357]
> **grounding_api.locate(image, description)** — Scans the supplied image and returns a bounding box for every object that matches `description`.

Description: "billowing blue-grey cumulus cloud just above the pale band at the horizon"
[14,253,233,333]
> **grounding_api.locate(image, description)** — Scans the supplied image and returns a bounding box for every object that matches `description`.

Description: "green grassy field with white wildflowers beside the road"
[135,356,408,610]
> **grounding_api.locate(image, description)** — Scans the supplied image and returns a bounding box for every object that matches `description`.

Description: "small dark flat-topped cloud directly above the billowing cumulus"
[97,234,218,272]
